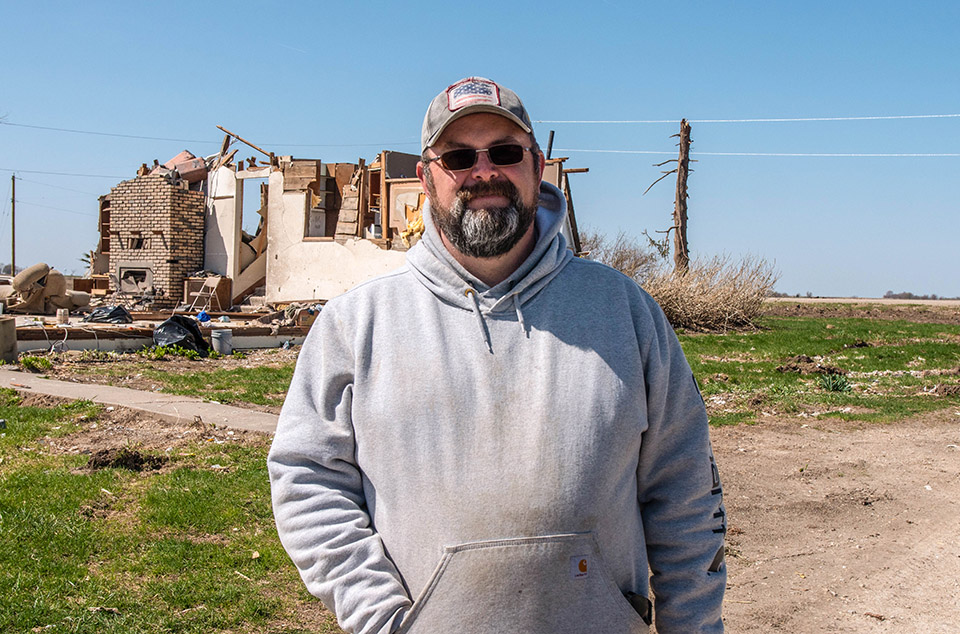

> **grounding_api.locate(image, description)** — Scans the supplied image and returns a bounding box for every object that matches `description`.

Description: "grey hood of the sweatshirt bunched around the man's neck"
[407,183,573,326]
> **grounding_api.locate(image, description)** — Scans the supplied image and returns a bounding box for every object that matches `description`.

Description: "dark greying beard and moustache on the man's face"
[427,178,537,258]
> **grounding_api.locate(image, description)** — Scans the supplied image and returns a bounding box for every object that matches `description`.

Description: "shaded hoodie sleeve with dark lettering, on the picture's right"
[637,297,726,634]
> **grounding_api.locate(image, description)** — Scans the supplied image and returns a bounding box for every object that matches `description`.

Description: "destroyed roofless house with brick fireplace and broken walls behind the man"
[88,133,586,310]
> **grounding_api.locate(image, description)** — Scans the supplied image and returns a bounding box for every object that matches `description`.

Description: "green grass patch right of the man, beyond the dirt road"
[680,317,960,424]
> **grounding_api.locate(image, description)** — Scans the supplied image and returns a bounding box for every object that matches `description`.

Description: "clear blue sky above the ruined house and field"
[0,0,960,297]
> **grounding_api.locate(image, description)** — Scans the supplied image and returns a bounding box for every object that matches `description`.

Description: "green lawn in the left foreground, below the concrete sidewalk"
[0,390,339,634]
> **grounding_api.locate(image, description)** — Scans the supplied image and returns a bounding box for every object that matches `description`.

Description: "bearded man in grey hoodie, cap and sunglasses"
[268,77,726,634]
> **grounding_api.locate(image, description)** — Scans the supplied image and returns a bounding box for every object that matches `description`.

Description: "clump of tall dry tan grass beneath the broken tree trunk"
[643,256,777,332]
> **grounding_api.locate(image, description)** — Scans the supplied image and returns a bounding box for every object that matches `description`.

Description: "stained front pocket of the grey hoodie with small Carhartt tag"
[399,533,647,634]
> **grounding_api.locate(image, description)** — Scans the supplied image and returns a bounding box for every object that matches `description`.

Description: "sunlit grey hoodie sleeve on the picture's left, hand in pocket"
[267,307,411,634]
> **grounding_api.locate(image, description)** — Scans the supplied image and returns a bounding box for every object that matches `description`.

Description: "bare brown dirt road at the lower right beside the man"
[713,410,960,634]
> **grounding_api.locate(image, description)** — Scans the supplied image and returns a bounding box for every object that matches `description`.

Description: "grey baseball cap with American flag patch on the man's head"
[420,77,533,151]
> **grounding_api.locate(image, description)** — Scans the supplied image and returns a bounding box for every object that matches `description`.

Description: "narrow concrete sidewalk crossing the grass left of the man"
[0,369,277,434]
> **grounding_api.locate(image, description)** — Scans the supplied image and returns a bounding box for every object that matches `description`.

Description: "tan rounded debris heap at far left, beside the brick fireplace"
[0,262,90,315]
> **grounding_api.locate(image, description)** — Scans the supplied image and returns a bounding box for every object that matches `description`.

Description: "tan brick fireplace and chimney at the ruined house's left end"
[109,174,205,309]
